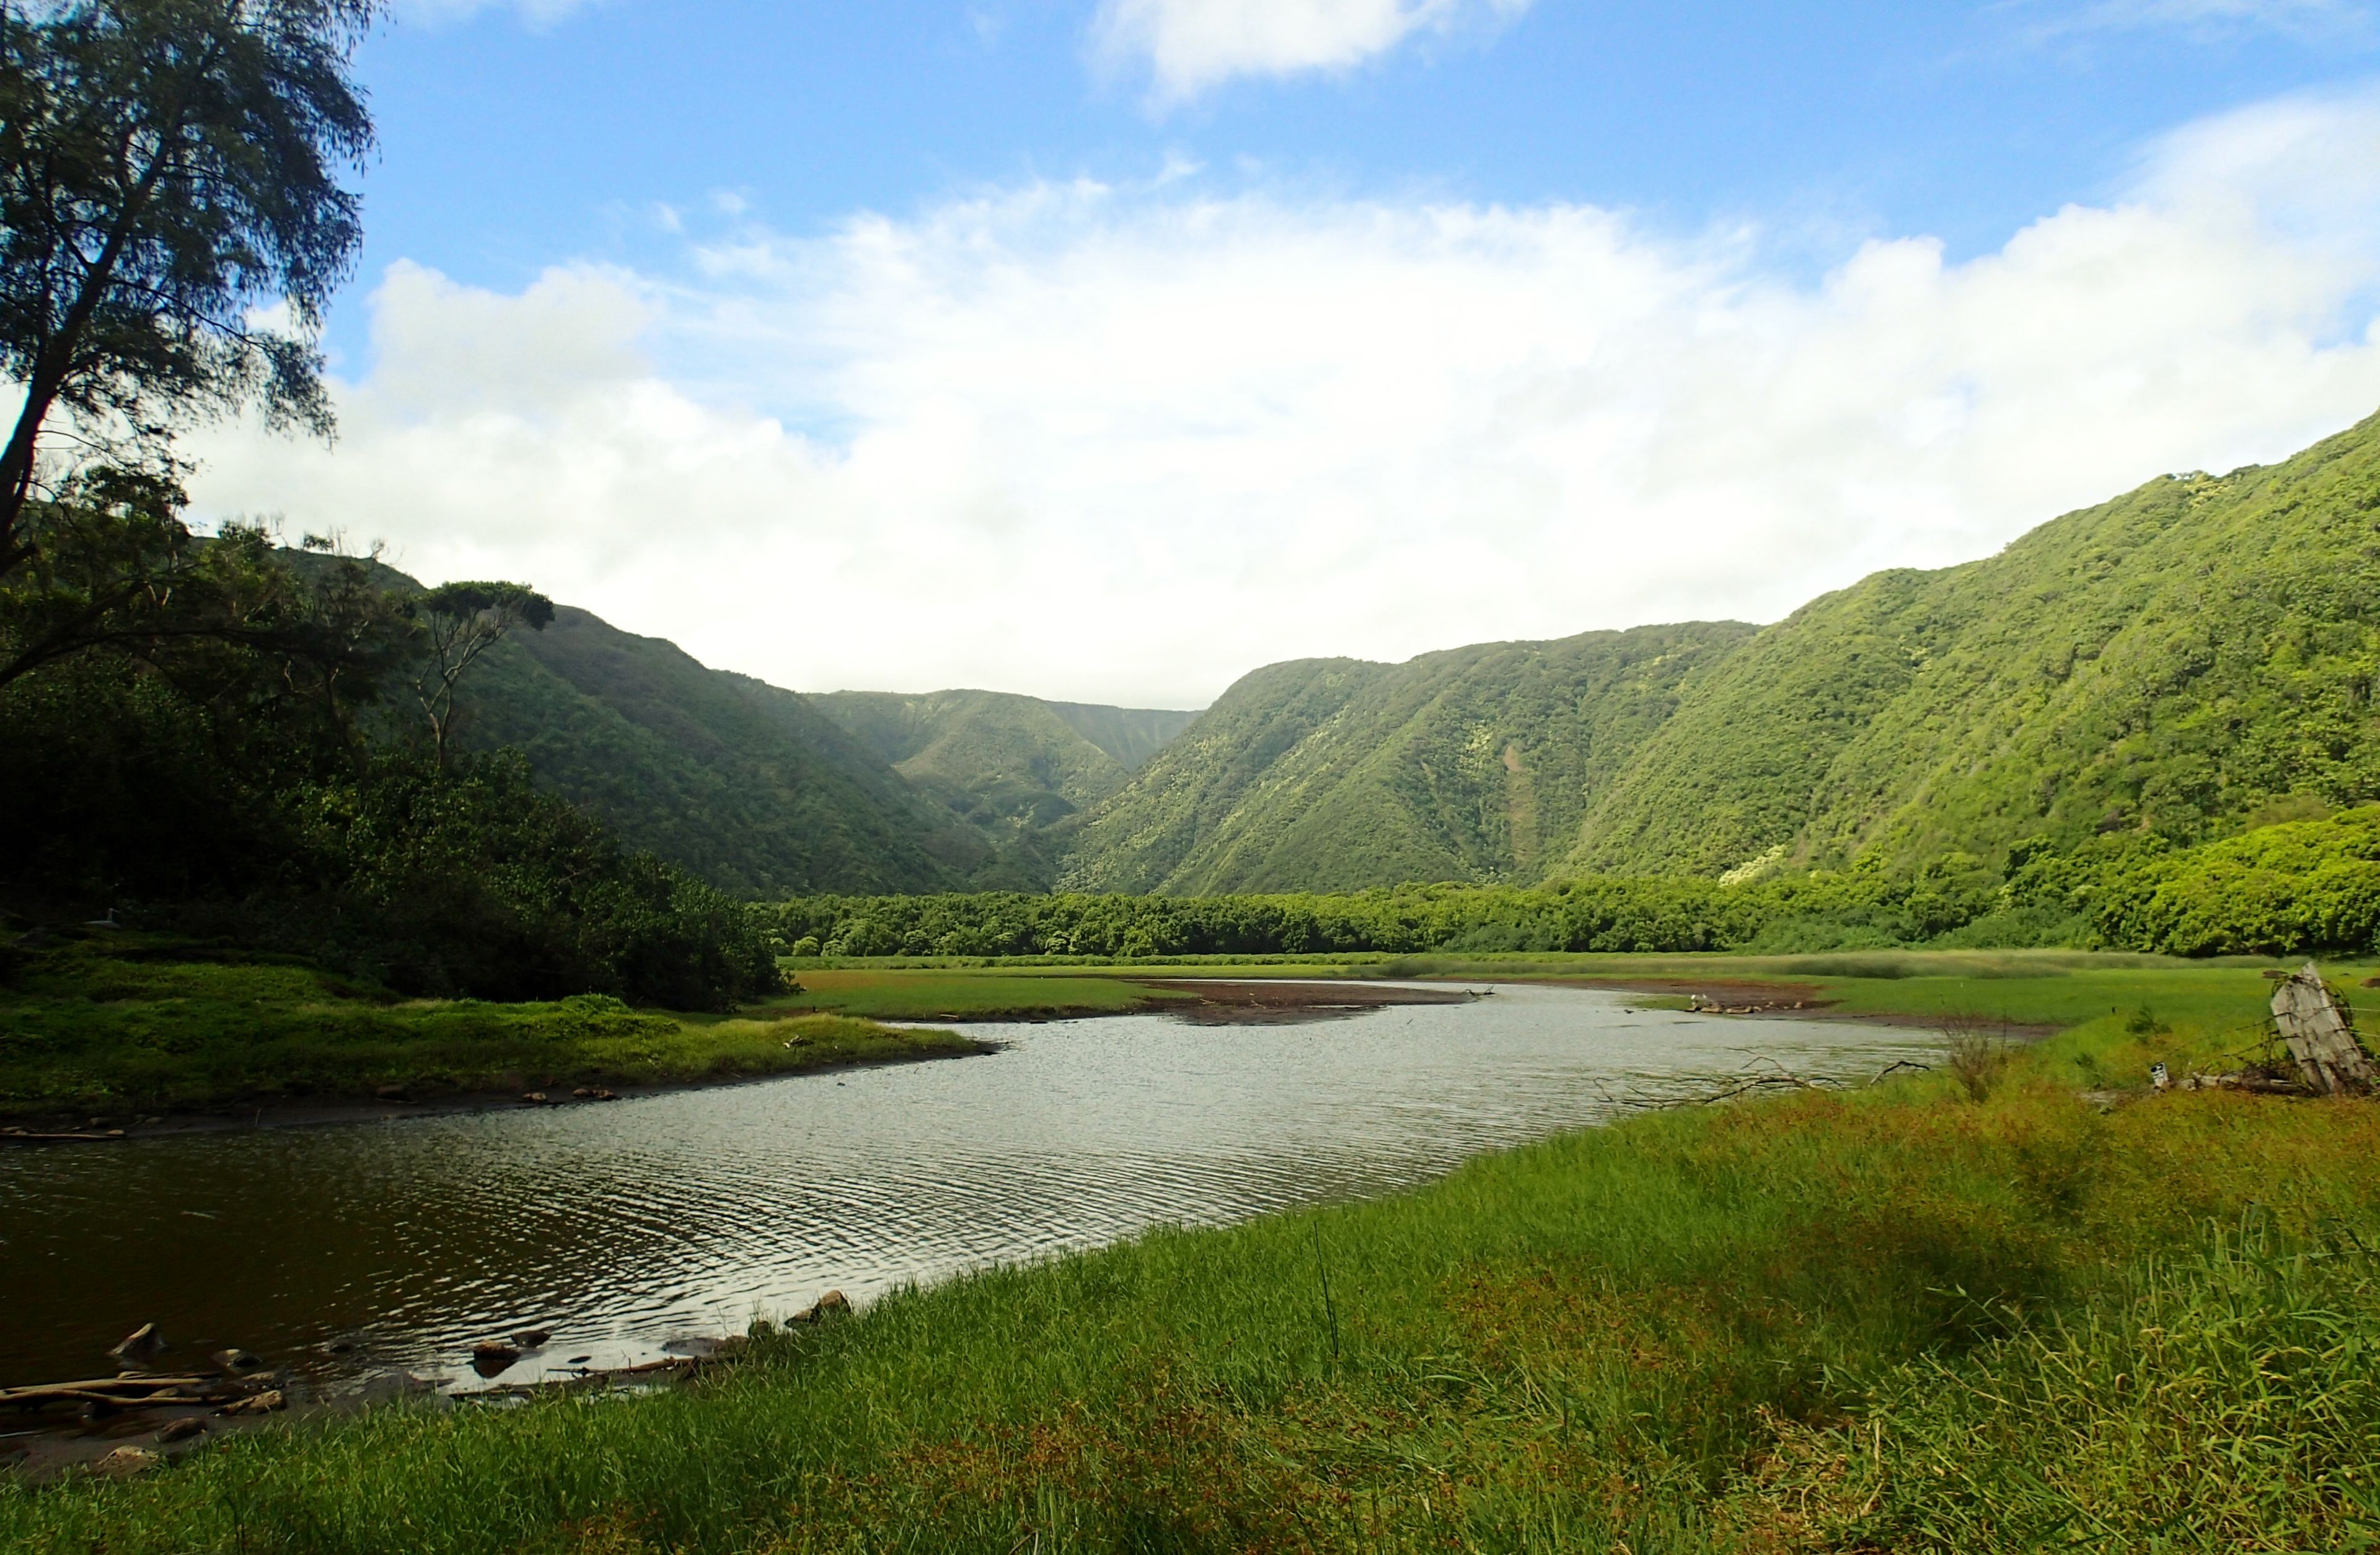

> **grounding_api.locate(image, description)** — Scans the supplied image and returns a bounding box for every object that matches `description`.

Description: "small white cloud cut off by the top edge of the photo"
[1093,0,1530,102]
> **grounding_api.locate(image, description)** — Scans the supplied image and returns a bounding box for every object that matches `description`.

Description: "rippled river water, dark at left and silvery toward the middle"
[0,986,1923,1383]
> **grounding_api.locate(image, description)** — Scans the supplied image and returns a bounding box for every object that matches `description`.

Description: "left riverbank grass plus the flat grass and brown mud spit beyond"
[0,936,1464,1143]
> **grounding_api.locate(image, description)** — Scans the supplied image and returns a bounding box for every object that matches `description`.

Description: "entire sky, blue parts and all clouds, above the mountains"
[190,0,2380,707]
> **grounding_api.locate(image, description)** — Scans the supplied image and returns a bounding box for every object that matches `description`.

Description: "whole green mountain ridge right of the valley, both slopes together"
[1064,416,2380,893]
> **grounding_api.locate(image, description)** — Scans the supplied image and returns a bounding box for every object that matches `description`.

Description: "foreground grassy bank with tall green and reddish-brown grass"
[0,969,2380,1555]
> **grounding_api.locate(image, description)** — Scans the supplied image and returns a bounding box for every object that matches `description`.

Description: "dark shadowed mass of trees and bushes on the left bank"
[0,514,783,1007]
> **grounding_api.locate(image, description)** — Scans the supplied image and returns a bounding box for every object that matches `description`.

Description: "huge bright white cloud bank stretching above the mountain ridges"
[198,88,2380,705]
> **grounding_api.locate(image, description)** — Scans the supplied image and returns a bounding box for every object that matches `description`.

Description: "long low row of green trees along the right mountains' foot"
[778,805,2380,958]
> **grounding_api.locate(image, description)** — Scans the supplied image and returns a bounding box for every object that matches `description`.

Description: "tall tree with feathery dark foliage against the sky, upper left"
[0,0,379,579]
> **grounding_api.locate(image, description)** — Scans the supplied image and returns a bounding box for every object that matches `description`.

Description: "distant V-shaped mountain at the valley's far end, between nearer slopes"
[811,690,1197,891]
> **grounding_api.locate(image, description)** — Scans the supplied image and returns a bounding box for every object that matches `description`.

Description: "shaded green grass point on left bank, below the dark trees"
[0,941,978,1122]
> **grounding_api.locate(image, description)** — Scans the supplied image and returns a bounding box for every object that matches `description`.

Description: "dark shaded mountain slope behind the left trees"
[462,605,992,896]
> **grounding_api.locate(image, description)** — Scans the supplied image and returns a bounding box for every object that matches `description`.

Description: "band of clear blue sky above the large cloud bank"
[350,0,2380,322]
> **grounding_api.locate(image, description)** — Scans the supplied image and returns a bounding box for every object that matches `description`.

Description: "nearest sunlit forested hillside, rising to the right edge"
[1566,419,2380,874]
